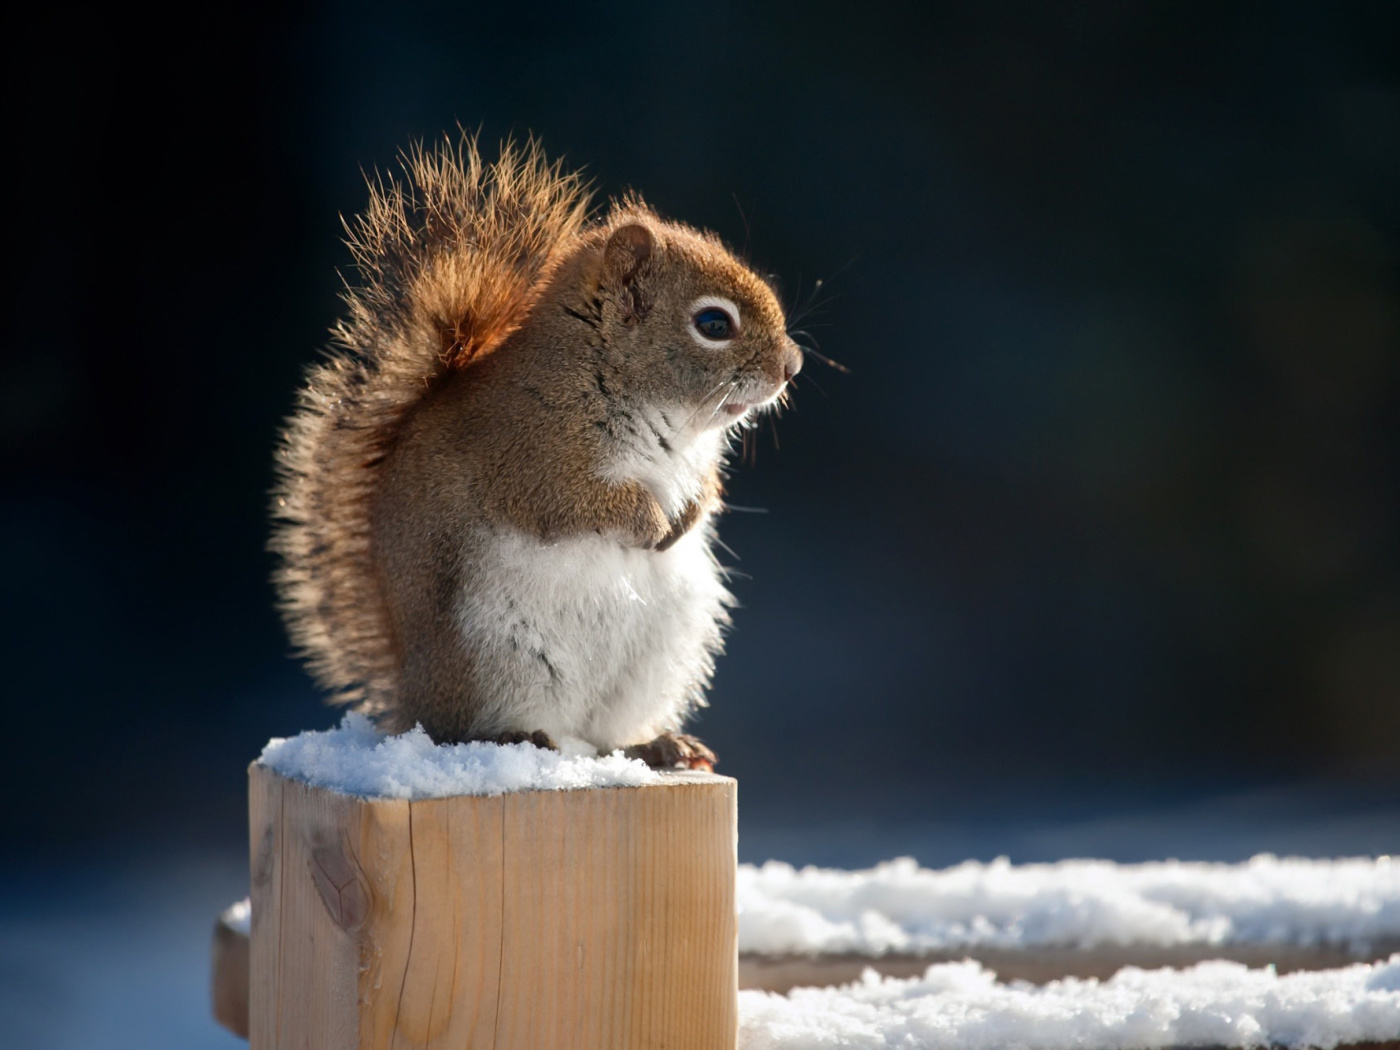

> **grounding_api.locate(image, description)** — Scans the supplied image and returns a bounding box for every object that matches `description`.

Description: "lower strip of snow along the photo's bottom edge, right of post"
[739,955,1400,1050]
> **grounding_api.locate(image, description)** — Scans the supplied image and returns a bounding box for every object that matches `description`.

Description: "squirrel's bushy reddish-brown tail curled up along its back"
[272,136,588,713]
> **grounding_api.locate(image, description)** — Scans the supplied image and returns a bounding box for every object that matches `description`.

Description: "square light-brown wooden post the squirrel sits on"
[249,763,738,1050]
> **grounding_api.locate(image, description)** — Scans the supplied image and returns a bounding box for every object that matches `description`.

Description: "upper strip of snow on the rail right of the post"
[738,854,1400,955]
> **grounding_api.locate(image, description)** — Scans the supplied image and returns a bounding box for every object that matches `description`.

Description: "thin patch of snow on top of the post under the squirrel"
[258,714,659,798]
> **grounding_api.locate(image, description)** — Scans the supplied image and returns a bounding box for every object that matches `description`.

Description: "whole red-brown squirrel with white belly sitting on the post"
[272,134,802,769]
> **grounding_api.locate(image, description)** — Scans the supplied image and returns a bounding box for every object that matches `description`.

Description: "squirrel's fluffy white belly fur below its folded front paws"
[459,522,732,750]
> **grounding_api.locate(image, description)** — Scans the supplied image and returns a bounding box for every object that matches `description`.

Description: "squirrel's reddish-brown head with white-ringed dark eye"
[565,207,802,431]
